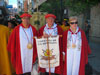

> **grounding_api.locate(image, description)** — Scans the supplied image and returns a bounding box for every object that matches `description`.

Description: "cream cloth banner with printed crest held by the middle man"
[36,36,60,68]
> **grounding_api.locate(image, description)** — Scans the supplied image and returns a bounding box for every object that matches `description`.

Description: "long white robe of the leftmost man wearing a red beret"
[19,26,33,73]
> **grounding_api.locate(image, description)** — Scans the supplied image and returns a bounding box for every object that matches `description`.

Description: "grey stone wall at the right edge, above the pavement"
[90,4,100,42]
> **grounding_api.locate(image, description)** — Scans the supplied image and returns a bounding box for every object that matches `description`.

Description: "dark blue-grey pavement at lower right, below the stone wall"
[88,41,100,75]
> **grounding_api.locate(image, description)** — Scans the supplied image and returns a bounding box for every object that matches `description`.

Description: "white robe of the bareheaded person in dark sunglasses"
[67,28,81,75]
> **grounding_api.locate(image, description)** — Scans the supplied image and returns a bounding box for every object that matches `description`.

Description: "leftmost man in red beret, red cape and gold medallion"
[8,13,37,75]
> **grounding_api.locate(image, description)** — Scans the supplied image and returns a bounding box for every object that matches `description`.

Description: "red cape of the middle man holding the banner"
[38,25,63,74]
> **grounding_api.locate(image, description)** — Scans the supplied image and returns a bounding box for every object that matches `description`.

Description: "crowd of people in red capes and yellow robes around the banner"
[0,13,91,75]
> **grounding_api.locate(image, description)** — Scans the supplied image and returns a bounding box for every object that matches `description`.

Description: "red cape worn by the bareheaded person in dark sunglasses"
[63,29,91,75]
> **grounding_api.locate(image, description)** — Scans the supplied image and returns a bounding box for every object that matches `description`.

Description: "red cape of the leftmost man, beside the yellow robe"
[7,24,37,74]
